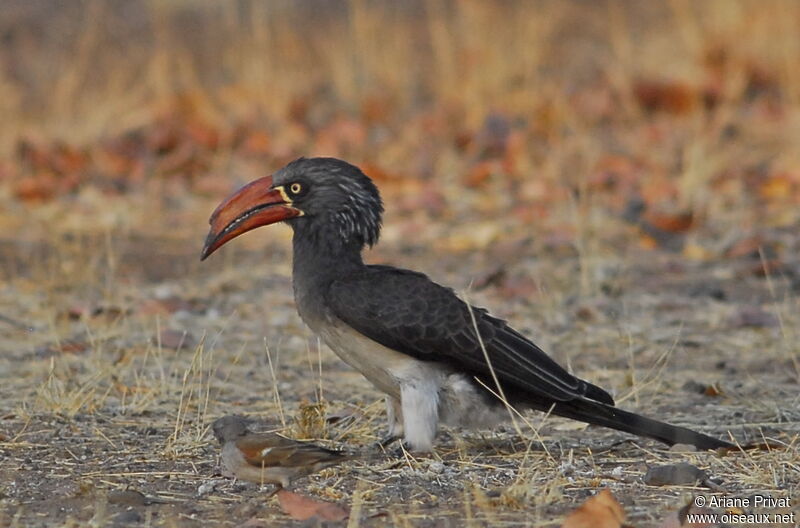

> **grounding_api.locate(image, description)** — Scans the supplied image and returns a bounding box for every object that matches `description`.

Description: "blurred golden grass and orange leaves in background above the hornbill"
[0,0,800,240]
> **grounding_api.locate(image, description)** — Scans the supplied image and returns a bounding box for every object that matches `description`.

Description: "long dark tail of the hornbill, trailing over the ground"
[552,400,736,450]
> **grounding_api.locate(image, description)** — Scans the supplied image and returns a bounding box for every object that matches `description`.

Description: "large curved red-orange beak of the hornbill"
[200,176,303,260]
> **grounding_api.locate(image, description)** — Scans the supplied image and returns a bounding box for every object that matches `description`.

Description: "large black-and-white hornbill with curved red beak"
[201,158,734,451]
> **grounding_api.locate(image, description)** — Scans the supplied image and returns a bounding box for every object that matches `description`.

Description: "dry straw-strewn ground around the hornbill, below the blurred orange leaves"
[0,203,800,527]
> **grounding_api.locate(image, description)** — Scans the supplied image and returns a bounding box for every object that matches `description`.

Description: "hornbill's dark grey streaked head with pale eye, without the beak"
[273,158,383,249]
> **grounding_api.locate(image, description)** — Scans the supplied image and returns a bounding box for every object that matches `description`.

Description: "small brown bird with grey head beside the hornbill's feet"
[211,416,353,490]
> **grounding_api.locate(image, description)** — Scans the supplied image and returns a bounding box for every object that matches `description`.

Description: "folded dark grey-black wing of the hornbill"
[326,266,614,409]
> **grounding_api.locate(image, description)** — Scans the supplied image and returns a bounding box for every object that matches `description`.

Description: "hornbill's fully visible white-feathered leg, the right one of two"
[400,378,439,452]
